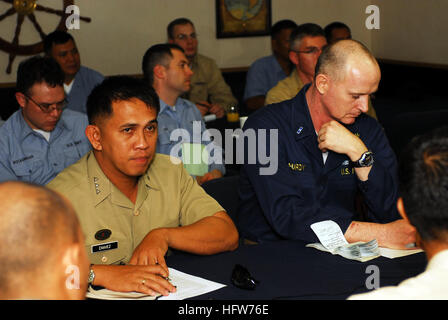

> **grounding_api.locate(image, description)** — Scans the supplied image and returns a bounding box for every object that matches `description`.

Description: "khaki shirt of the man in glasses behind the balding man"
[265,69,378,120]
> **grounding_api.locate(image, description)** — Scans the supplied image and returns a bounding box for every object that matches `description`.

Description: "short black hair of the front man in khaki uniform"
[87,76,160,124]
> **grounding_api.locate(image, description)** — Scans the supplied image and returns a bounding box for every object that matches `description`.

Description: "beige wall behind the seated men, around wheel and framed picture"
[0,0,448,83]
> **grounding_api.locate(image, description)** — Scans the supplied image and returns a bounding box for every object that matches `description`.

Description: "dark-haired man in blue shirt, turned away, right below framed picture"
[243,20,297,110]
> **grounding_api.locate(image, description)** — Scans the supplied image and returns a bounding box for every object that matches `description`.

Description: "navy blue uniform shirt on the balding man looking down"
[238,85,399,242]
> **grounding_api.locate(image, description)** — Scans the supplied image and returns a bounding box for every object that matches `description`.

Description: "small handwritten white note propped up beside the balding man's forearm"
[311,220,348,253]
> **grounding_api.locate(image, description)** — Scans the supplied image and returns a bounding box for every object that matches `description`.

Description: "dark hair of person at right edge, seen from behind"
[398,126,448,241]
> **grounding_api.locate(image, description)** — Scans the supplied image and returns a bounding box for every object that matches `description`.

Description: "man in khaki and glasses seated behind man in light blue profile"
[167,18,238,118]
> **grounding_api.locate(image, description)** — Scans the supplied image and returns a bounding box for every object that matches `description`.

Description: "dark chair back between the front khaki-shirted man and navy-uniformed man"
[202,175,240,223]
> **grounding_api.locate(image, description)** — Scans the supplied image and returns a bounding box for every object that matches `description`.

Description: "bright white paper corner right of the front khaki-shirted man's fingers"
[159,268,226,300]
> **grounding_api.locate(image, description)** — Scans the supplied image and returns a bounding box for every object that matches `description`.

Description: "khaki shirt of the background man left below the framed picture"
[186,54,238,111]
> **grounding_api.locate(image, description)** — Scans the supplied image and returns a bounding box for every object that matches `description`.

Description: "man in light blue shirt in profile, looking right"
[142,44,225,184]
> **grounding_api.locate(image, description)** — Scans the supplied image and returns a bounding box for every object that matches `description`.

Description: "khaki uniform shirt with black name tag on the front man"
[48,152,224,264]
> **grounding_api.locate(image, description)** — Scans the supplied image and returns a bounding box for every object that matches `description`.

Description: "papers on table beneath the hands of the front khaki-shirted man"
[86,268,226,300]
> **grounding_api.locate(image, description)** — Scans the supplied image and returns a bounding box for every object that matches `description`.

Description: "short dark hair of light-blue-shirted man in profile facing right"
[142,43,185,86]
